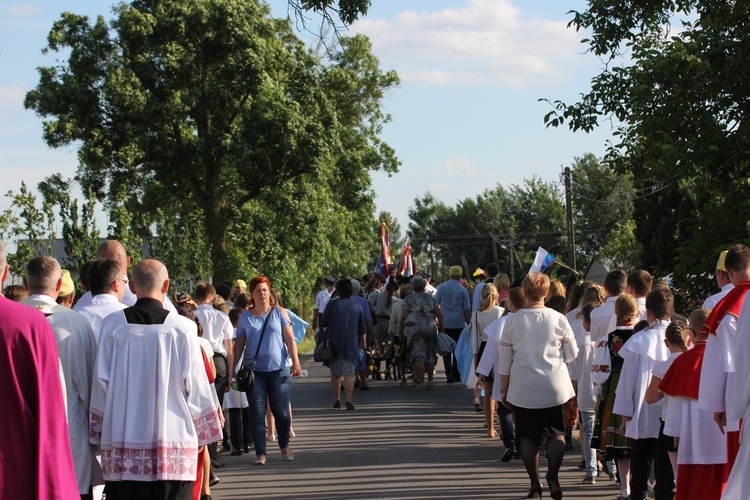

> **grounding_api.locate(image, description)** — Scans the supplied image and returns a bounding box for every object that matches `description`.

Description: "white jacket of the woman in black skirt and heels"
[498,307,578,409]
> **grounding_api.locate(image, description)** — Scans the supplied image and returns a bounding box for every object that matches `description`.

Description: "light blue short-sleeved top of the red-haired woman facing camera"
[237,307,291,372]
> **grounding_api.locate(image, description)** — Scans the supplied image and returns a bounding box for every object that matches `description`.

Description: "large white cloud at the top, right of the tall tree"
[352,0,580,87]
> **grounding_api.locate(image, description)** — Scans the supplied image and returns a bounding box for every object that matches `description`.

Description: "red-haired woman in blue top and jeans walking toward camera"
[230,276,302,465]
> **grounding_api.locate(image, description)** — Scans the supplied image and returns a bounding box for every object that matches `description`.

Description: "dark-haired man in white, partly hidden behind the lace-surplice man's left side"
[76,259,128,342]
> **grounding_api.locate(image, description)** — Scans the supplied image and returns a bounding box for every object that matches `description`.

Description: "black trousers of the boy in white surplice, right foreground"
[630,432,674,500]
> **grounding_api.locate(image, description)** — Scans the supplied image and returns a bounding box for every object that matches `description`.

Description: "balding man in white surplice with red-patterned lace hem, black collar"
[89,259,221,500]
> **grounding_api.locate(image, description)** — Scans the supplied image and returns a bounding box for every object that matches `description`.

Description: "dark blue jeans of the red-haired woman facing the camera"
[247,367,292,456]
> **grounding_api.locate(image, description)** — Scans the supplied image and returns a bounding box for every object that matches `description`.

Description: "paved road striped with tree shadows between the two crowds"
[212,359,618,499]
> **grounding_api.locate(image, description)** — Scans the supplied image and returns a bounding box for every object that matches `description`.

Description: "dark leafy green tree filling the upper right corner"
[545,0,750,286]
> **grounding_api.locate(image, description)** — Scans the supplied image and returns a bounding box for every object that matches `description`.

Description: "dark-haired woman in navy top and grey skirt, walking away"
[320,279,367,410]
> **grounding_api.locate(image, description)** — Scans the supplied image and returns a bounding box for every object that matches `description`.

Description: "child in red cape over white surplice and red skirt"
[659,309,727,500]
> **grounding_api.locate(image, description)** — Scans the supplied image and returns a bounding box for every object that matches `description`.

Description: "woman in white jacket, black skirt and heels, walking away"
[498,273,578,500]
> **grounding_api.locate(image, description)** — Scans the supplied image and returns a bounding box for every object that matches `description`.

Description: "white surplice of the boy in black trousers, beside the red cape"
[612,321,669,439]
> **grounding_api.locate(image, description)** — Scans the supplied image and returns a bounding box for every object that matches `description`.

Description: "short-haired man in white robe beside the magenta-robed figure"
[23,257,102,496]
